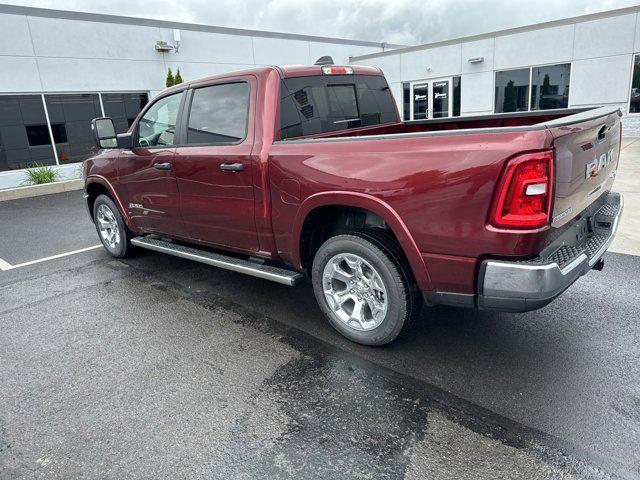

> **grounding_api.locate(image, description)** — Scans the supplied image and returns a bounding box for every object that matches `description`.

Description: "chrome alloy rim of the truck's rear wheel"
[322,253,388,331]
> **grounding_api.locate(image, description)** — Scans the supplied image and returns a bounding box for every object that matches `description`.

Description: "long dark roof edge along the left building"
[0,3,407,49]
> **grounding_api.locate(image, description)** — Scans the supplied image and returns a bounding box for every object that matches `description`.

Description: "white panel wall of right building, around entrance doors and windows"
[351,7,640,136]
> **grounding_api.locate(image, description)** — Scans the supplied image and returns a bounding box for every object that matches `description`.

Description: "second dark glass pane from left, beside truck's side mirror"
[45,94,102,165]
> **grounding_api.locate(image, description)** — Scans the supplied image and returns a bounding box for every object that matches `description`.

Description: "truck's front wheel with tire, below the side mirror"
[93,195,133,258]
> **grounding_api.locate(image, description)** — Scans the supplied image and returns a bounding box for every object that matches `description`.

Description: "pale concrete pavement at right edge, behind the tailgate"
[609,138,640,255]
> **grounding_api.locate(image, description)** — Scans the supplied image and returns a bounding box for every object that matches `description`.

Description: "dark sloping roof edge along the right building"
[351,5,640,61]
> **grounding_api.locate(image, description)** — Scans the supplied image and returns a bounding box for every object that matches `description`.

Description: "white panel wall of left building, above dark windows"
[0,9,390,94]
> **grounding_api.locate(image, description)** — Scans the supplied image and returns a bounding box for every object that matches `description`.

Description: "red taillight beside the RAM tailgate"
[491,150,553,228]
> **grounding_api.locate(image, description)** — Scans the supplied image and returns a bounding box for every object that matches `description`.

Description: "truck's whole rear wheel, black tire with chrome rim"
[311,231,422,345]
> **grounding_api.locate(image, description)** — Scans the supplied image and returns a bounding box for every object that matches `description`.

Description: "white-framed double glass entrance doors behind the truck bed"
[410,78,452,120]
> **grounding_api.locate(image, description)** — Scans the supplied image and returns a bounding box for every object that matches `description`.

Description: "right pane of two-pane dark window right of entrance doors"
[531,63,571,110]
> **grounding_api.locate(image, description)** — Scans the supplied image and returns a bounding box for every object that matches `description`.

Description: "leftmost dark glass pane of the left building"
[0,95,56,171]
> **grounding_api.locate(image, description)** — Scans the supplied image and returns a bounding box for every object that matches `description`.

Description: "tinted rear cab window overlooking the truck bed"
[280,75,398,140]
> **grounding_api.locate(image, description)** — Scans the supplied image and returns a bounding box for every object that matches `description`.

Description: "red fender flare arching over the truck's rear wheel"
[291,191,432,290]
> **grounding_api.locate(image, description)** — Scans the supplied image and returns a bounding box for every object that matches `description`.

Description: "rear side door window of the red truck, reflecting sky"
[186,82,249,145]
